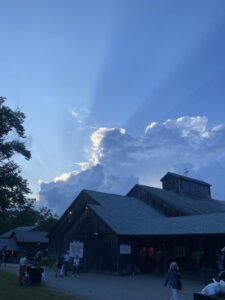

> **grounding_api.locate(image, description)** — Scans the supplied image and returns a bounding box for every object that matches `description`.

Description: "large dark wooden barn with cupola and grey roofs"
[49,173,225,274]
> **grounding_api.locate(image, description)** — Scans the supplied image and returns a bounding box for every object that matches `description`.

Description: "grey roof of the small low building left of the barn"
[15,230,48,243]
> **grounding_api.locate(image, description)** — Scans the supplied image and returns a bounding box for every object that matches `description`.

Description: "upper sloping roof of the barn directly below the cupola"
[128,184,225,215]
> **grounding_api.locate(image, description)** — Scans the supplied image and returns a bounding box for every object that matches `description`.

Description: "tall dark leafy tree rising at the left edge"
[0,97,31,217]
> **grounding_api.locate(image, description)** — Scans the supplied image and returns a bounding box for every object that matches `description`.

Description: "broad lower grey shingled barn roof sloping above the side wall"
[85,191,225,236]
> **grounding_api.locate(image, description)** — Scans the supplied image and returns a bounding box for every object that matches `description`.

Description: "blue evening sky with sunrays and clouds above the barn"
[0,0,225,215]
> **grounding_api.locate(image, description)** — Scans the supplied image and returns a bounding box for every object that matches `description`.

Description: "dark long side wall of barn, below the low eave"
[115,235,225,274]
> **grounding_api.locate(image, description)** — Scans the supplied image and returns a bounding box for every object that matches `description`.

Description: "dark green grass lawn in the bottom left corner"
[0,270,84,300]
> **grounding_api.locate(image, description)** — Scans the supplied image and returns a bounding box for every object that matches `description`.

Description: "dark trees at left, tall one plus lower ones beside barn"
[0,97,58,233]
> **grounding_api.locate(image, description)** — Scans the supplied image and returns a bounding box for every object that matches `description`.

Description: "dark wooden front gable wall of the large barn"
[50,208,118,273]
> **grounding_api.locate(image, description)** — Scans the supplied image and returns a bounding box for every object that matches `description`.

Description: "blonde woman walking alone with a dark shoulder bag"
[165,262,180,300]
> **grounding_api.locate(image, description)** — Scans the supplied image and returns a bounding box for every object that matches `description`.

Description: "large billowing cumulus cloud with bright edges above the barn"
[40,116,225,212]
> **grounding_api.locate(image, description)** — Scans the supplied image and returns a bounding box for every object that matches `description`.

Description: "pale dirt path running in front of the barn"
[1,265,204,300]
